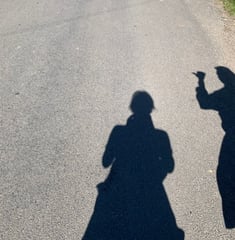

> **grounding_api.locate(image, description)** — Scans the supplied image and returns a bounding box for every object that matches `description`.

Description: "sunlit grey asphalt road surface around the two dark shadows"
[0,0,235,240]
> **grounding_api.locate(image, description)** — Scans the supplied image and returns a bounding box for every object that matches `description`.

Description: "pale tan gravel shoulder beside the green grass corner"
[186,0,235,70]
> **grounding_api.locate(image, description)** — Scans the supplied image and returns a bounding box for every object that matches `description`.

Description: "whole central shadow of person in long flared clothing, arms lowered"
[83,91,184,240]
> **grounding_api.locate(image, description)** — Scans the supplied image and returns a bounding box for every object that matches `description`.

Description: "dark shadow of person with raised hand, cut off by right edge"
[194,66,235,229]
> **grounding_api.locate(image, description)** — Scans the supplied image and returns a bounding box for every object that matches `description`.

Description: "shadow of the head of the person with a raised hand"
[215,66,235,86]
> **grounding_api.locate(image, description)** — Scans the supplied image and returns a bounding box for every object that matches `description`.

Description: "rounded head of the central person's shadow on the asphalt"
[130,91,155,115]
